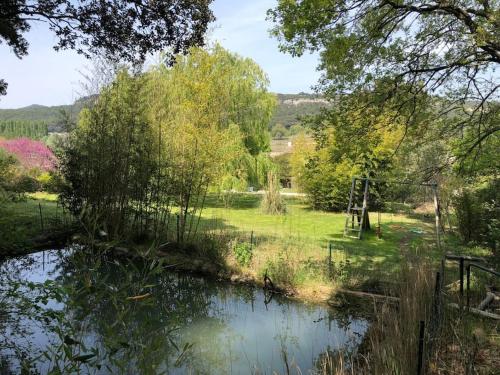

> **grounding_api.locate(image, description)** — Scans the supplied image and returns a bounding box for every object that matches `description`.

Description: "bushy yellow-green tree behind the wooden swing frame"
[291,98,404,211]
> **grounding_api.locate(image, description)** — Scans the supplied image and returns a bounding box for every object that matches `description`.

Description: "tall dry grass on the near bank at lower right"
[321,260,500,375]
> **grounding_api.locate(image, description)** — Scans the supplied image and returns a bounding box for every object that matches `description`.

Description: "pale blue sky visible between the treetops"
[0,0,320,108]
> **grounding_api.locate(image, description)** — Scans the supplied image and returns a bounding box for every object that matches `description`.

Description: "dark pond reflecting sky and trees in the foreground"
[0,248,368,374]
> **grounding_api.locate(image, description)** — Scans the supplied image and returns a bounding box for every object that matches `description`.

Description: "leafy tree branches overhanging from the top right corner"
[268,0,500,163]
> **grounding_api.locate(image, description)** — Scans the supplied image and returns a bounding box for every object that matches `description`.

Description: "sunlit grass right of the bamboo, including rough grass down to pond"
[197,194,441,295]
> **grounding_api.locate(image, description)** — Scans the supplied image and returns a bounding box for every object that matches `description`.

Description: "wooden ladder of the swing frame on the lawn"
[344,177,370,240]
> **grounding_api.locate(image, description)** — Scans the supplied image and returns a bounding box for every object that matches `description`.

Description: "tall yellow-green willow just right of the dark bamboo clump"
[149,45,276,241]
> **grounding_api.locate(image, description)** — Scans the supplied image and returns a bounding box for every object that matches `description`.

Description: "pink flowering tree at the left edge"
[0,138,57,171]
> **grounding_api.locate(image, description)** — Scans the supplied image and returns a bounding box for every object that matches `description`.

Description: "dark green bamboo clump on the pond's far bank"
[60,71,155,237]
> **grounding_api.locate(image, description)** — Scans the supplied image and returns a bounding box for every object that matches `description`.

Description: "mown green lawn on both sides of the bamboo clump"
[0,193,478,296]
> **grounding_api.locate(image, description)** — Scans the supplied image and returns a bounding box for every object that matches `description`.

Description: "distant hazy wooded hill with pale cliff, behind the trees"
[0,93,328,132]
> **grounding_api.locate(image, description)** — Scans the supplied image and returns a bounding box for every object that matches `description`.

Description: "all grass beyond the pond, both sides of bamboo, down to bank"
[0,192,490,299]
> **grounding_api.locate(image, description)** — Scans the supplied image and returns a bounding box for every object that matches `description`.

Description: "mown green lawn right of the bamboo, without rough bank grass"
[202,194,441,286]
